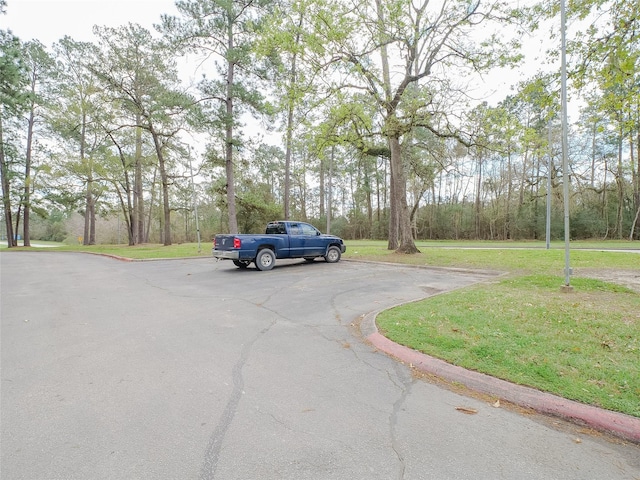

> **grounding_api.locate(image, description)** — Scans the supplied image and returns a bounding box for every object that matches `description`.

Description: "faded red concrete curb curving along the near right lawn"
[360,311,640,444]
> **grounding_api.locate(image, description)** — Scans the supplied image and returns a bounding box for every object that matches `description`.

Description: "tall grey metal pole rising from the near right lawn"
[560,0,571,291]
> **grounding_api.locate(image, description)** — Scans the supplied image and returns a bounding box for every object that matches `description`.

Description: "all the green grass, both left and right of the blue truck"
[5,241,640,417]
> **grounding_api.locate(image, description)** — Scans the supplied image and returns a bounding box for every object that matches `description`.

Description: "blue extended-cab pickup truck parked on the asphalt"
[211,222,347,270]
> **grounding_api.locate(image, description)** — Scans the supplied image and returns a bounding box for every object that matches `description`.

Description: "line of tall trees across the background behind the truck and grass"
[0,0,640,248]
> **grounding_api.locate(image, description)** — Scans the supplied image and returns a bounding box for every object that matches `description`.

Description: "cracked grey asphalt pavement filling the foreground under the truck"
[0,251,640,480]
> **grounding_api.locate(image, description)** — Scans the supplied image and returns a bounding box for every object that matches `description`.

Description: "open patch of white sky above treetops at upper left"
[0,0,177,47]
